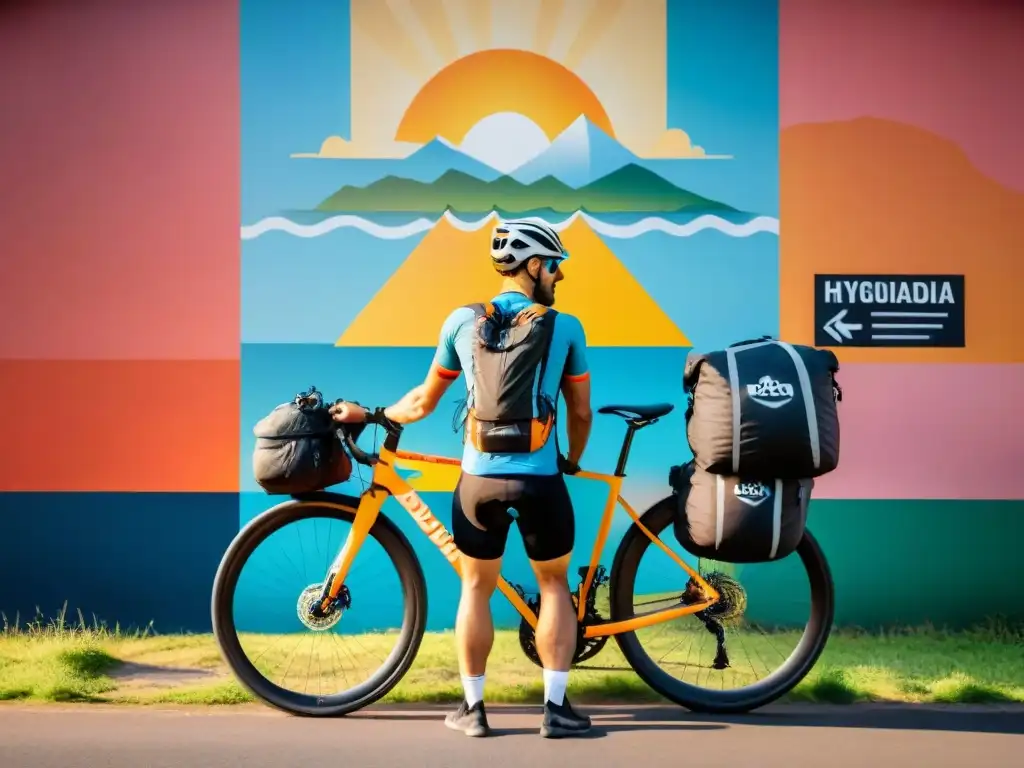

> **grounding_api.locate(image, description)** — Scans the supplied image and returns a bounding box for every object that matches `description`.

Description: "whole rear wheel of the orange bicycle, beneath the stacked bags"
[609,496,835,714]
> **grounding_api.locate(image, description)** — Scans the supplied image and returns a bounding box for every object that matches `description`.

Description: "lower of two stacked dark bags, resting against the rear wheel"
[674,467,814,563]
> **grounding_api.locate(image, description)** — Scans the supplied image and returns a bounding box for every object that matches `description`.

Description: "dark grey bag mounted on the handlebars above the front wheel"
[253,390,352,495]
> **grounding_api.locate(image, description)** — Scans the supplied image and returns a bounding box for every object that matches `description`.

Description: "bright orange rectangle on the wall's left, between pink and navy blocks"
[0,360,239,492]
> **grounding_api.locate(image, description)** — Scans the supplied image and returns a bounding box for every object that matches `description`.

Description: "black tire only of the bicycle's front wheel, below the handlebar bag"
[211,493,427,717]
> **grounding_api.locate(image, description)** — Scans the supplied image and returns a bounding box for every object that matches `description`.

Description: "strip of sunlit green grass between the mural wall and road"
[0,614,1024,705]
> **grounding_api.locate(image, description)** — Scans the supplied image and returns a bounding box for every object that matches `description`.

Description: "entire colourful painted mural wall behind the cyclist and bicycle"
[0,0,1024,631]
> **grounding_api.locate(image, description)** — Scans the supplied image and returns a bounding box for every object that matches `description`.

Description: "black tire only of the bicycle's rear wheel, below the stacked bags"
[609,496,835,715]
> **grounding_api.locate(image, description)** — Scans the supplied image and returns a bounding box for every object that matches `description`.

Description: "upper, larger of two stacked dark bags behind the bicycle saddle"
[683,338,842,480]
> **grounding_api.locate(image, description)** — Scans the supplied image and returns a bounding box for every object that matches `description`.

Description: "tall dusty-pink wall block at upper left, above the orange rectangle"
[0,2,240,360]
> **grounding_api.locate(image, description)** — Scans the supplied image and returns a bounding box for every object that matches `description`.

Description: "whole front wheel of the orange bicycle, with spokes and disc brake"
[211,494,427,717]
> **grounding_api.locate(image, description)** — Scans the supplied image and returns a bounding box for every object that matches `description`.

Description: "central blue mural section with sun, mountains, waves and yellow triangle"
[237,0,779,628]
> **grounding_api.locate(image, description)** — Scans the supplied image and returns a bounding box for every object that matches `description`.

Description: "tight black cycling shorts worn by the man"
[452,472,575,562]
